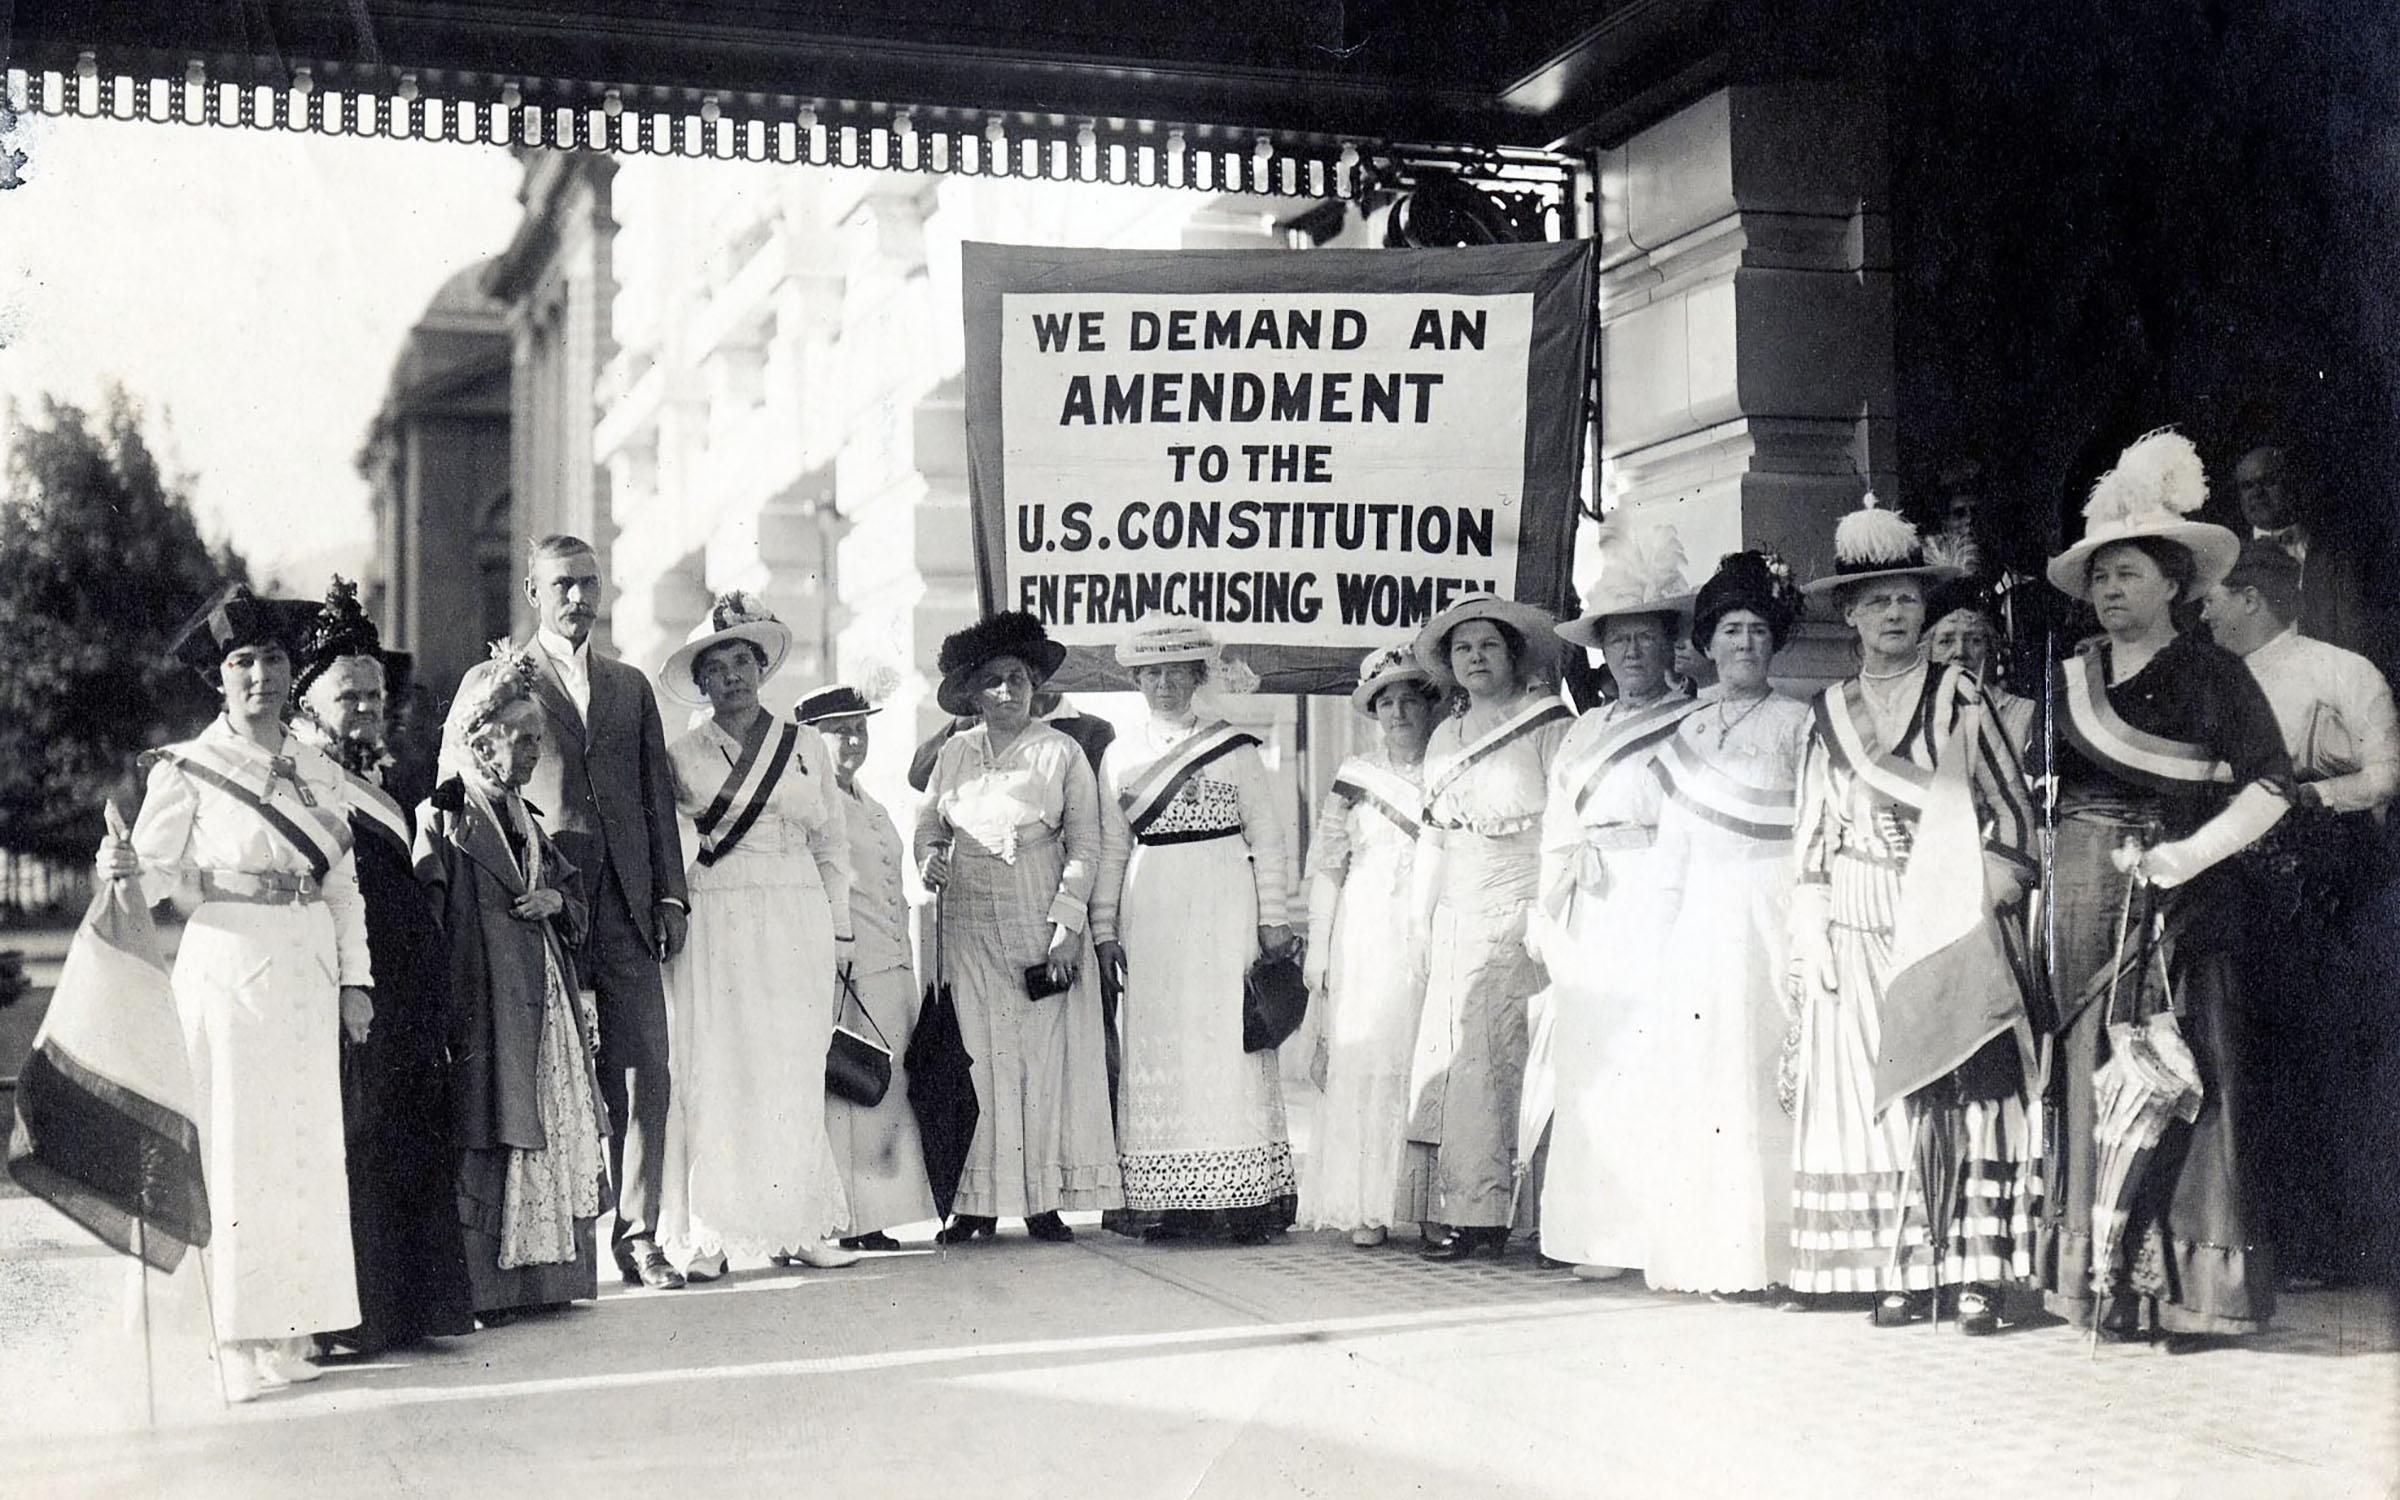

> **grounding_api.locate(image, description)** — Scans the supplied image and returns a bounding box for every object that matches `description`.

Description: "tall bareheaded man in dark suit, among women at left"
[526,535,691,1291]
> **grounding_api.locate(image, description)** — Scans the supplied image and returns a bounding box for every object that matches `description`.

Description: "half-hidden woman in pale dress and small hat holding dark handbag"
[816,684,934,1250]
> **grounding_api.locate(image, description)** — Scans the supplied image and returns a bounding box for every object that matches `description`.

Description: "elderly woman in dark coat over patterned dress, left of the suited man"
[418,643,607,1325]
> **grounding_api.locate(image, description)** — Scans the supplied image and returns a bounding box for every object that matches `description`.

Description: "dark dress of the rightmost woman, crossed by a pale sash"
[2040,636,2292,1334]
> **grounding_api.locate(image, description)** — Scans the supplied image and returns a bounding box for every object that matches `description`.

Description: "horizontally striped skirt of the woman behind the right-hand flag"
[1790,850,2040,1291]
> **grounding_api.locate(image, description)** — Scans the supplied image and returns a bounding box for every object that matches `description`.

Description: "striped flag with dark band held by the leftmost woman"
[7,804,209,1272]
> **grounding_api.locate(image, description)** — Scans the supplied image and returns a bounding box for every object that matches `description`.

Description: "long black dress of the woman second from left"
[336,778,475,1351]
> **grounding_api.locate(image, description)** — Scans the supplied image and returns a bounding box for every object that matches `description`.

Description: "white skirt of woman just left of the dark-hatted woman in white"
[1541,847,1661,1265]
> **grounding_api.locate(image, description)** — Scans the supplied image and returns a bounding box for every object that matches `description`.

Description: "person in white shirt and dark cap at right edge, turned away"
[2203,538,2400,1291]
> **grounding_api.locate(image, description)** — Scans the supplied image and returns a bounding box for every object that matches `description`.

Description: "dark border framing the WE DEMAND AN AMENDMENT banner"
[960,240,1598,694]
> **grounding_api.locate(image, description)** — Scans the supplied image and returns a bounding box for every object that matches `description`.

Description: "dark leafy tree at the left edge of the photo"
[0,389,245,859]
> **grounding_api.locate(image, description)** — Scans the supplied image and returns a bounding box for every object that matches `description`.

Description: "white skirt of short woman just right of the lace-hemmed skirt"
[1301,847,1426,1229]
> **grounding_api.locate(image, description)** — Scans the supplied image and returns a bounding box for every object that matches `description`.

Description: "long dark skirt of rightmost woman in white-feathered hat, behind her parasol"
[2040,814,2275,1334]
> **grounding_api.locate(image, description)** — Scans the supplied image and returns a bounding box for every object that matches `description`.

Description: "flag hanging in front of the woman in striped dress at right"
[1874,701,2033,1114]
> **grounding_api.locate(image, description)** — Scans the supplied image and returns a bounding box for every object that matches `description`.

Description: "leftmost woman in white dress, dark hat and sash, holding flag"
[101,588,374,1402]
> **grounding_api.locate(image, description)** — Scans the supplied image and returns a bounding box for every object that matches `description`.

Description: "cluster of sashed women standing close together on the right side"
[1301,432,2290,1339]
